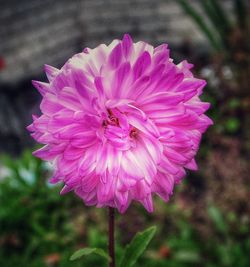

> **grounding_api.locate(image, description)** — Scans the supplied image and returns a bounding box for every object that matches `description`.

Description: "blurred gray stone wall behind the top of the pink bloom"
[0,0,215,83]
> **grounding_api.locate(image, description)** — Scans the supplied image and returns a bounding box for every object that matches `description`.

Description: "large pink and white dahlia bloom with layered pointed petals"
[28,34,212,212]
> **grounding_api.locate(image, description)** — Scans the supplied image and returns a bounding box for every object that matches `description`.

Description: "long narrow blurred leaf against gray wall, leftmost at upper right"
[178,0,223,51]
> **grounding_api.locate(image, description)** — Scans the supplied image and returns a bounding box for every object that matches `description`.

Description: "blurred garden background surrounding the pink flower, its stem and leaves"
[0,0,250,267]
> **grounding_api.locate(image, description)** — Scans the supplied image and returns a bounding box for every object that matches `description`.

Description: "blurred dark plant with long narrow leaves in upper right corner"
[177,0,250,101]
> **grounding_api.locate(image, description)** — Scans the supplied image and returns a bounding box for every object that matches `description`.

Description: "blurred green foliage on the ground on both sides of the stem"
[0,151,250,267]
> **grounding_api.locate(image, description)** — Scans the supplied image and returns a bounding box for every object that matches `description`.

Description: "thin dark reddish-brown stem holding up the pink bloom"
[109,208,115,267]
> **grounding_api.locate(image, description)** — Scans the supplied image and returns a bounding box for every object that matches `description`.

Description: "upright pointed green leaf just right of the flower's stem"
[119,226,156,267]
